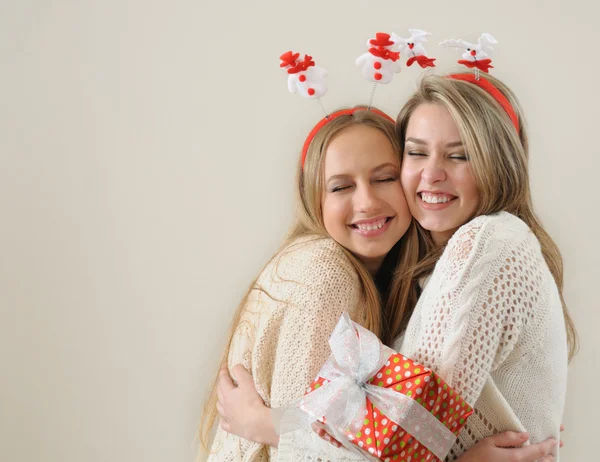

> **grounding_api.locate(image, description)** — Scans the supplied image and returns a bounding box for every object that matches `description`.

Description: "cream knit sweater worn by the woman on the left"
[208,238,364,462]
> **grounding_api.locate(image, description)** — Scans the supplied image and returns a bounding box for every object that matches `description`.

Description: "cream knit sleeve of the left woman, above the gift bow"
[253,240,361,407]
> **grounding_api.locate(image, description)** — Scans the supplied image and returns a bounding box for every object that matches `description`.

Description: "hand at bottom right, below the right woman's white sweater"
[457,432,558,462]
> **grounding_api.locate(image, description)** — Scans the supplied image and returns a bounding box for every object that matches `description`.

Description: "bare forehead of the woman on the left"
[325,125,400,177]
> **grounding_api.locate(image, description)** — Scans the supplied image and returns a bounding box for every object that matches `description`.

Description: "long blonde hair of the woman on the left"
[199,110,419,450]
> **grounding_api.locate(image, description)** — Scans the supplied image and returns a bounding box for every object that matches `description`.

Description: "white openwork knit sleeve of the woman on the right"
[403,213,538,405]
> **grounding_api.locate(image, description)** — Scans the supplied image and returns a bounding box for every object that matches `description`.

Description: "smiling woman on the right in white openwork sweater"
[200,31,576,460]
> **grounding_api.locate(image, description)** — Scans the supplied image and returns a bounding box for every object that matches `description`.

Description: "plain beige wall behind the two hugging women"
[0,0,600,462]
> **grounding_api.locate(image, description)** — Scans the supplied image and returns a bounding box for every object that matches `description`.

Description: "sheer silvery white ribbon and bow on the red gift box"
[273,313,456,460]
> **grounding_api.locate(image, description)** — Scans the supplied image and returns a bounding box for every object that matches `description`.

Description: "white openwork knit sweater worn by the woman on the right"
[279,212,567,462]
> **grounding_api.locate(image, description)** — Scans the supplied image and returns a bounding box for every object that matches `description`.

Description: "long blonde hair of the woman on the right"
[396,74,578,358]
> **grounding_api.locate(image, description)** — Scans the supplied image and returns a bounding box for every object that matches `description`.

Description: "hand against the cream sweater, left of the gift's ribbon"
[217,364,279,447]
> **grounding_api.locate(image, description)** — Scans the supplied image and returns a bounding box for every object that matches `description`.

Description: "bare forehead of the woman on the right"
[405,103,460,143]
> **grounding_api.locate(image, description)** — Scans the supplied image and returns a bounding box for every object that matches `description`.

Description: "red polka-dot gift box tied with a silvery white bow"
[300,315,473,462]
